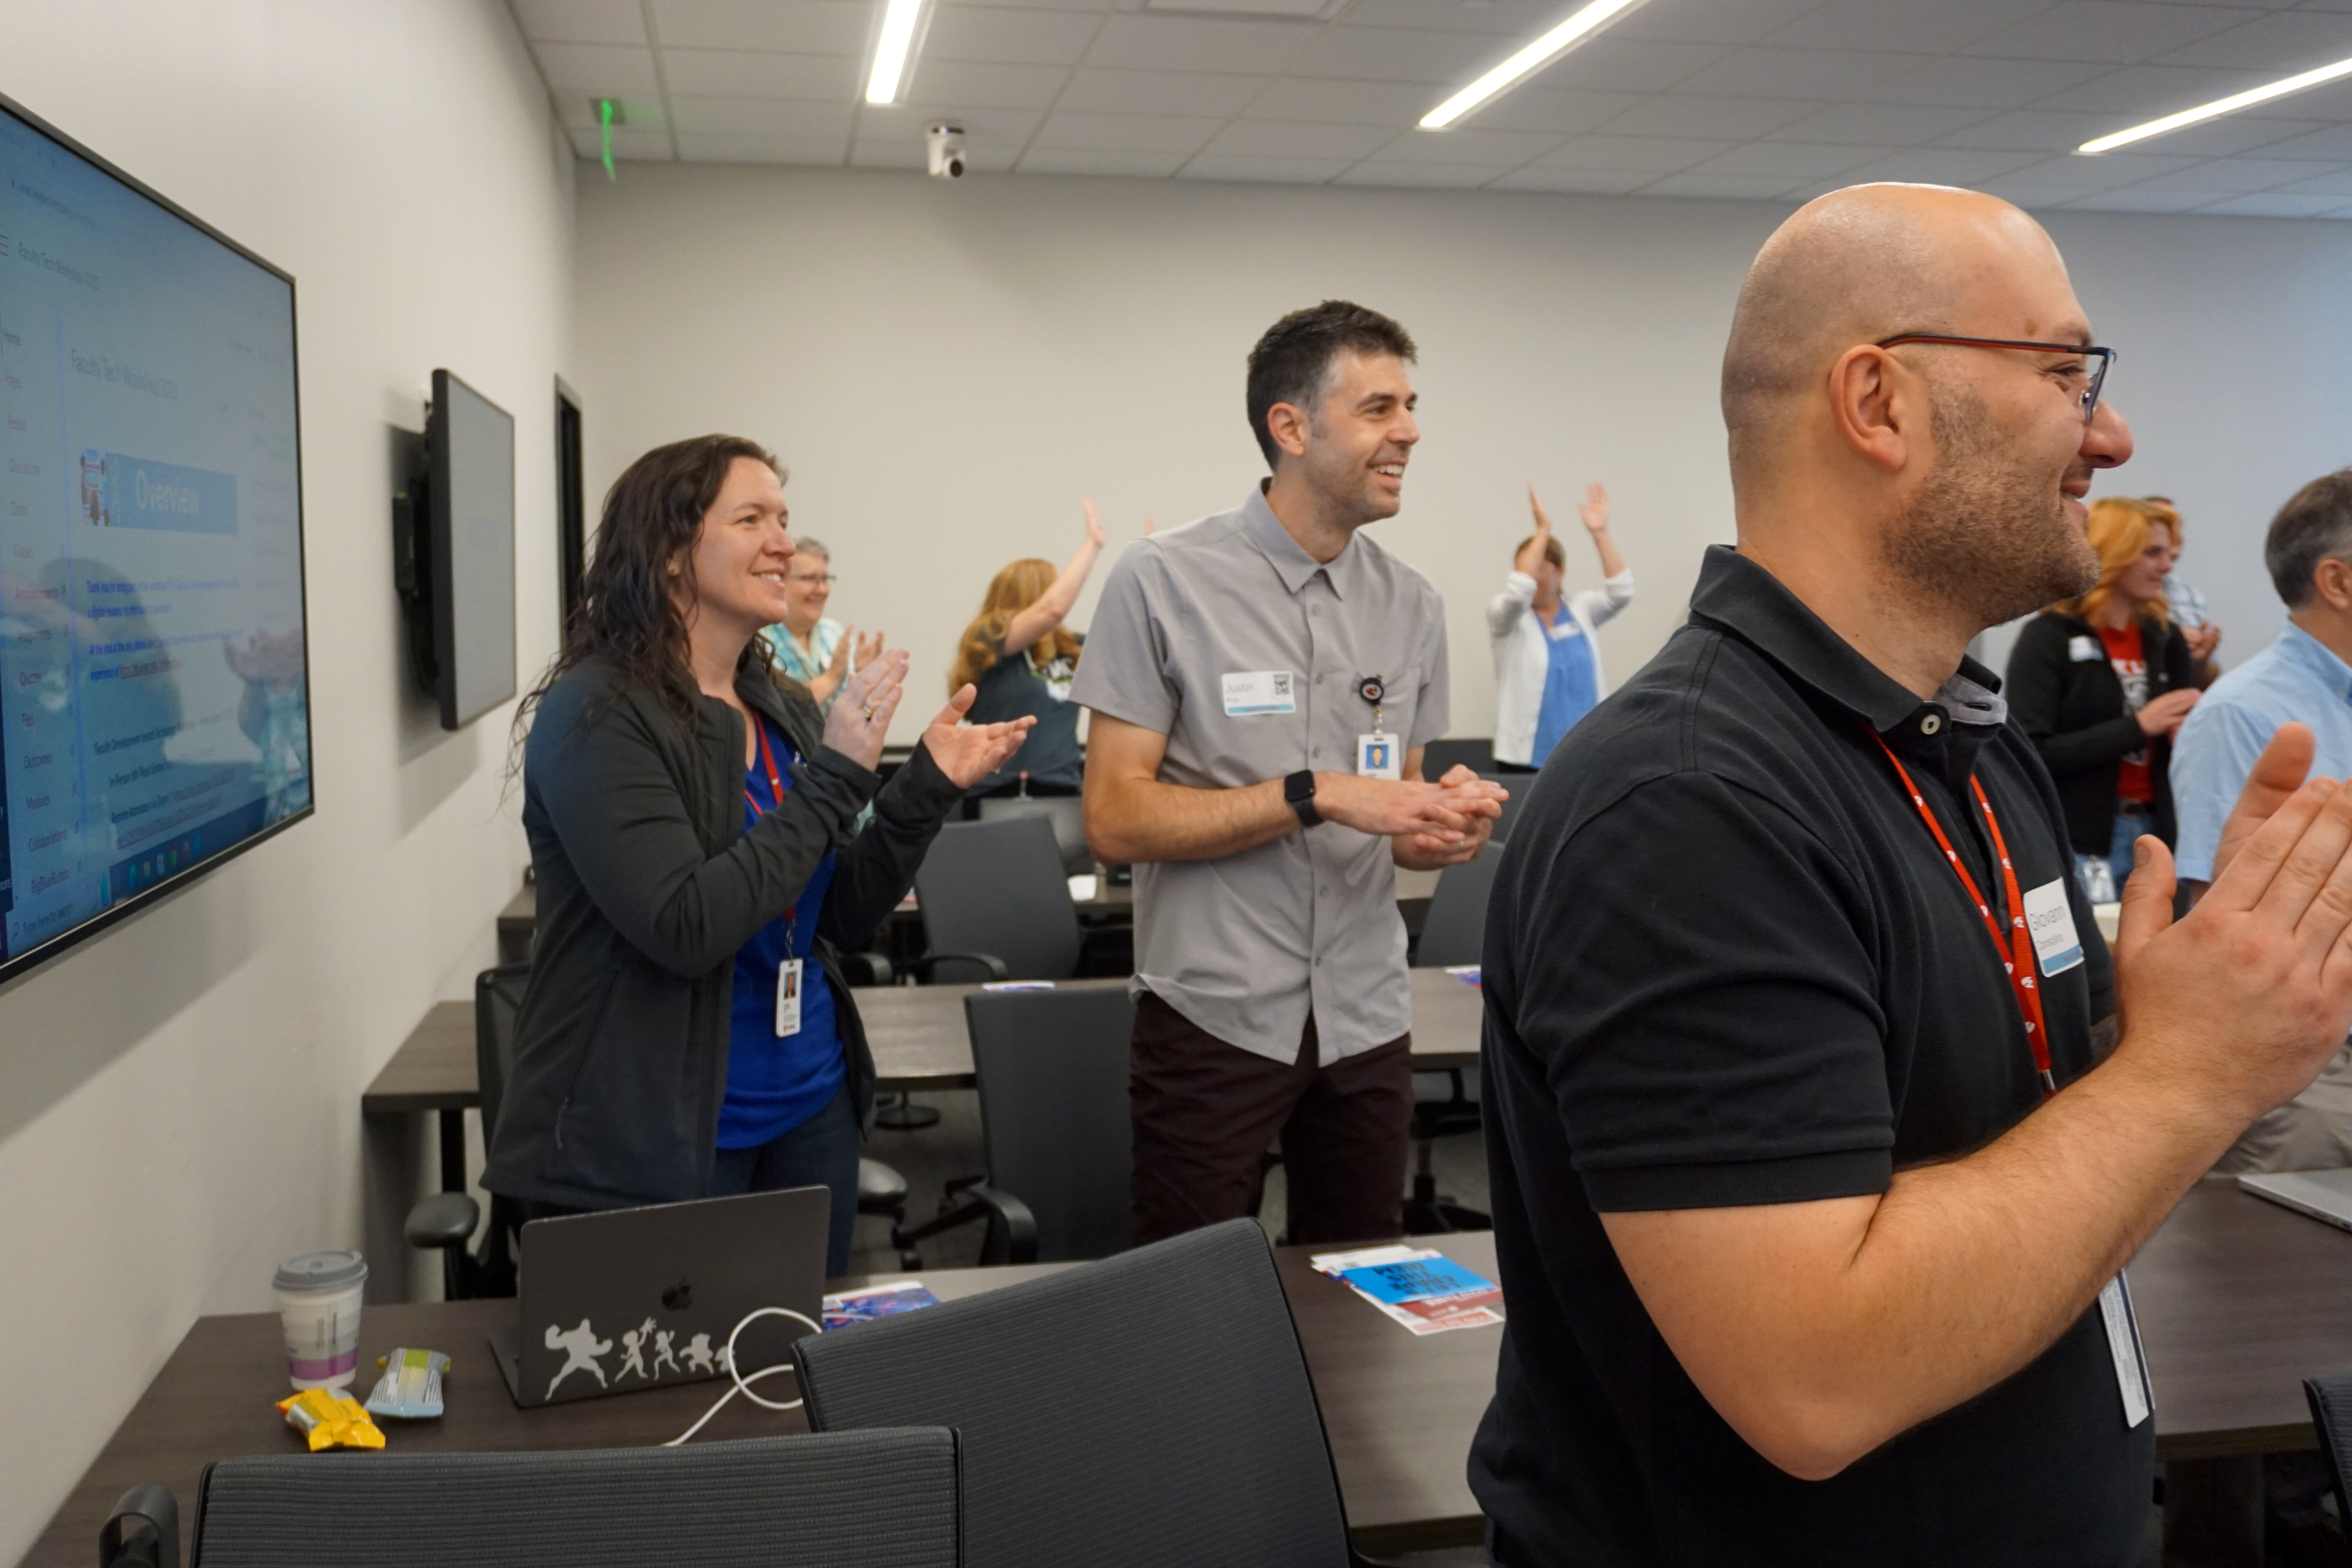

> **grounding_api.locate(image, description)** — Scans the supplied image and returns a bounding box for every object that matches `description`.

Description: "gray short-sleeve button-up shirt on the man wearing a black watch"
[1073,489,1449,1065]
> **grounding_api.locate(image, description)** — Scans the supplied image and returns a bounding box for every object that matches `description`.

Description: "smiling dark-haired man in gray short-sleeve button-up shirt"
[1073,301,1503,1241]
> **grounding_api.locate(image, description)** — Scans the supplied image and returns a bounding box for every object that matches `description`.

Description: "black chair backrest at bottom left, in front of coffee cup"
[193,1439,962,1568]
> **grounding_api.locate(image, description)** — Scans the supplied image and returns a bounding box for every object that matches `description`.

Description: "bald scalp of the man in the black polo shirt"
[1724,186,2065,491]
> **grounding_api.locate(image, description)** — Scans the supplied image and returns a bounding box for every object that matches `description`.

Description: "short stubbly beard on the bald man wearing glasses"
[1884,386,2098,628]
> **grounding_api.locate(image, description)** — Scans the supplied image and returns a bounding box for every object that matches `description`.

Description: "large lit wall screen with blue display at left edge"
[0,99,310,978]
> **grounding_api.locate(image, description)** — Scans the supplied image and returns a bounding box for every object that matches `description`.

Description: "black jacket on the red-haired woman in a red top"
[2004,609,2197,856]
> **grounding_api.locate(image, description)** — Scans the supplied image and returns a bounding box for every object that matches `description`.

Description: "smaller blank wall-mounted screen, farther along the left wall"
[426,369,515,729]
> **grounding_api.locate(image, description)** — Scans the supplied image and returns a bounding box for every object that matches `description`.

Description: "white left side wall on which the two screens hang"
[0,0,574,1561]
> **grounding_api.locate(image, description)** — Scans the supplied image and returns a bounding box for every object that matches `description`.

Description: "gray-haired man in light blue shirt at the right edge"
[2173,468,2352,1173]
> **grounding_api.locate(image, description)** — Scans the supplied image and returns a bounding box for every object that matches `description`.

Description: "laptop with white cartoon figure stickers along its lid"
[489,1187,833,1406]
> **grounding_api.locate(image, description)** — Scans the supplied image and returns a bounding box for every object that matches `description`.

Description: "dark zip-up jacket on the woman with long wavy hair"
[482,661,962,1208]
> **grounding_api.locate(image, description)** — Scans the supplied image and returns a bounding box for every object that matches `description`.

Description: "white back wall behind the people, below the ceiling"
[579,165,2352,740]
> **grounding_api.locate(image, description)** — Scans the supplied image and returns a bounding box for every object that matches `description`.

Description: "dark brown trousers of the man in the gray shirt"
[1127,992,1414,1246]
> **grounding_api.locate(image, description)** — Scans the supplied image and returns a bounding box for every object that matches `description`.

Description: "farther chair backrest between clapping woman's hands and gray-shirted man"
[915,816,1080,980]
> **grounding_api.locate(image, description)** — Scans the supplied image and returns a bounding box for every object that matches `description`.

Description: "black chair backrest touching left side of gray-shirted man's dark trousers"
[964,985,1136,1262]
